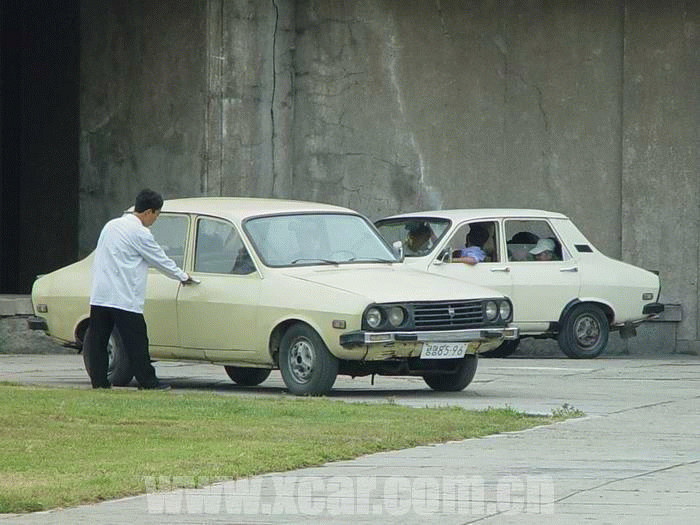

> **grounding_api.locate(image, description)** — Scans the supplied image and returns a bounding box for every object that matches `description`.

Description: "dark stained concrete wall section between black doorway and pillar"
[80,0,209,255]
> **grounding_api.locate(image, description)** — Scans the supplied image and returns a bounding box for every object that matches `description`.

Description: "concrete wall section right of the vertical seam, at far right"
[622,2,700,352]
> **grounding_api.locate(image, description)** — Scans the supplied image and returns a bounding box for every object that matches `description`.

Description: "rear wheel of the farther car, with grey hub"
[558,304,610,359]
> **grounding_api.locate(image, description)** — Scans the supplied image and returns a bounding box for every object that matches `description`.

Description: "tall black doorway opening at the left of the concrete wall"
[0,0,80,293]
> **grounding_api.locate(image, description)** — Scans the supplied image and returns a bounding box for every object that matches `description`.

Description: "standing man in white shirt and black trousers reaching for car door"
[83,189,195,390]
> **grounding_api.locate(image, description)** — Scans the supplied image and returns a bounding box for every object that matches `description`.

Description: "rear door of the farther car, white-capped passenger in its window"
[504,218,581,331]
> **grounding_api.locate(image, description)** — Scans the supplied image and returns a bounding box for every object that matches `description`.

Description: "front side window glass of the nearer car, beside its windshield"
[194,218,255,275]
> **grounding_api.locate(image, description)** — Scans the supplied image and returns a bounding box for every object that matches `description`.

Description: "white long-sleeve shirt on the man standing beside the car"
[90,213,188,313]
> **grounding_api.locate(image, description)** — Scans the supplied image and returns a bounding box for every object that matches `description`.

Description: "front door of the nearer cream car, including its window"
[177,217,262,362]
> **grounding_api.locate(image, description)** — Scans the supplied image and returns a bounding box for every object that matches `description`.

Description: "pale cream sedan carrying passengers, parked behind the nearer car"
[376,209,663,358]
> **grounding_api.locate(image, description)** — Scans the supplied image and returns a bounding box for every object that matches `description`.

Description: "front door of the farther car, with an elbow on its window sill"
[430,220,512,297]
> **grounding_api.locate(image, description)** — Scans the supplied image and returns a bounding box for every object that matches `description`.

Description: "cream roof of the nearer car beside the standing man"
[154,197,355,221]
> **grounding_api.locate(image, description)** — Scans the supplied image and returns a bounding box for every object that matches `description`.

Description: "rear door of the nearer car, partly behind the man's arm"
[144,213,190,357]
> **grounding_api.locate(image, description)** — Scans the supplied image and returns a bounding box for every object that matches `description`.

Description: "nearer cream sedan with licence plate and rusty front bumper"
[32,198,517,395]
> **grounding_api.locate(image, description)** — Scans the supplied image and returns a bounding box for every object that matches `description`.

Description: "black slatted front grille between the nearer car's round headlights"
[412,301,484,330]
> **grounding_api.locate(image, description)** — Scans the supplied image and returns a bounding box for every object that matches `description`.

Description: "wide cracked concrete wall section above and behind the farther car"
[295,0,623,256]
